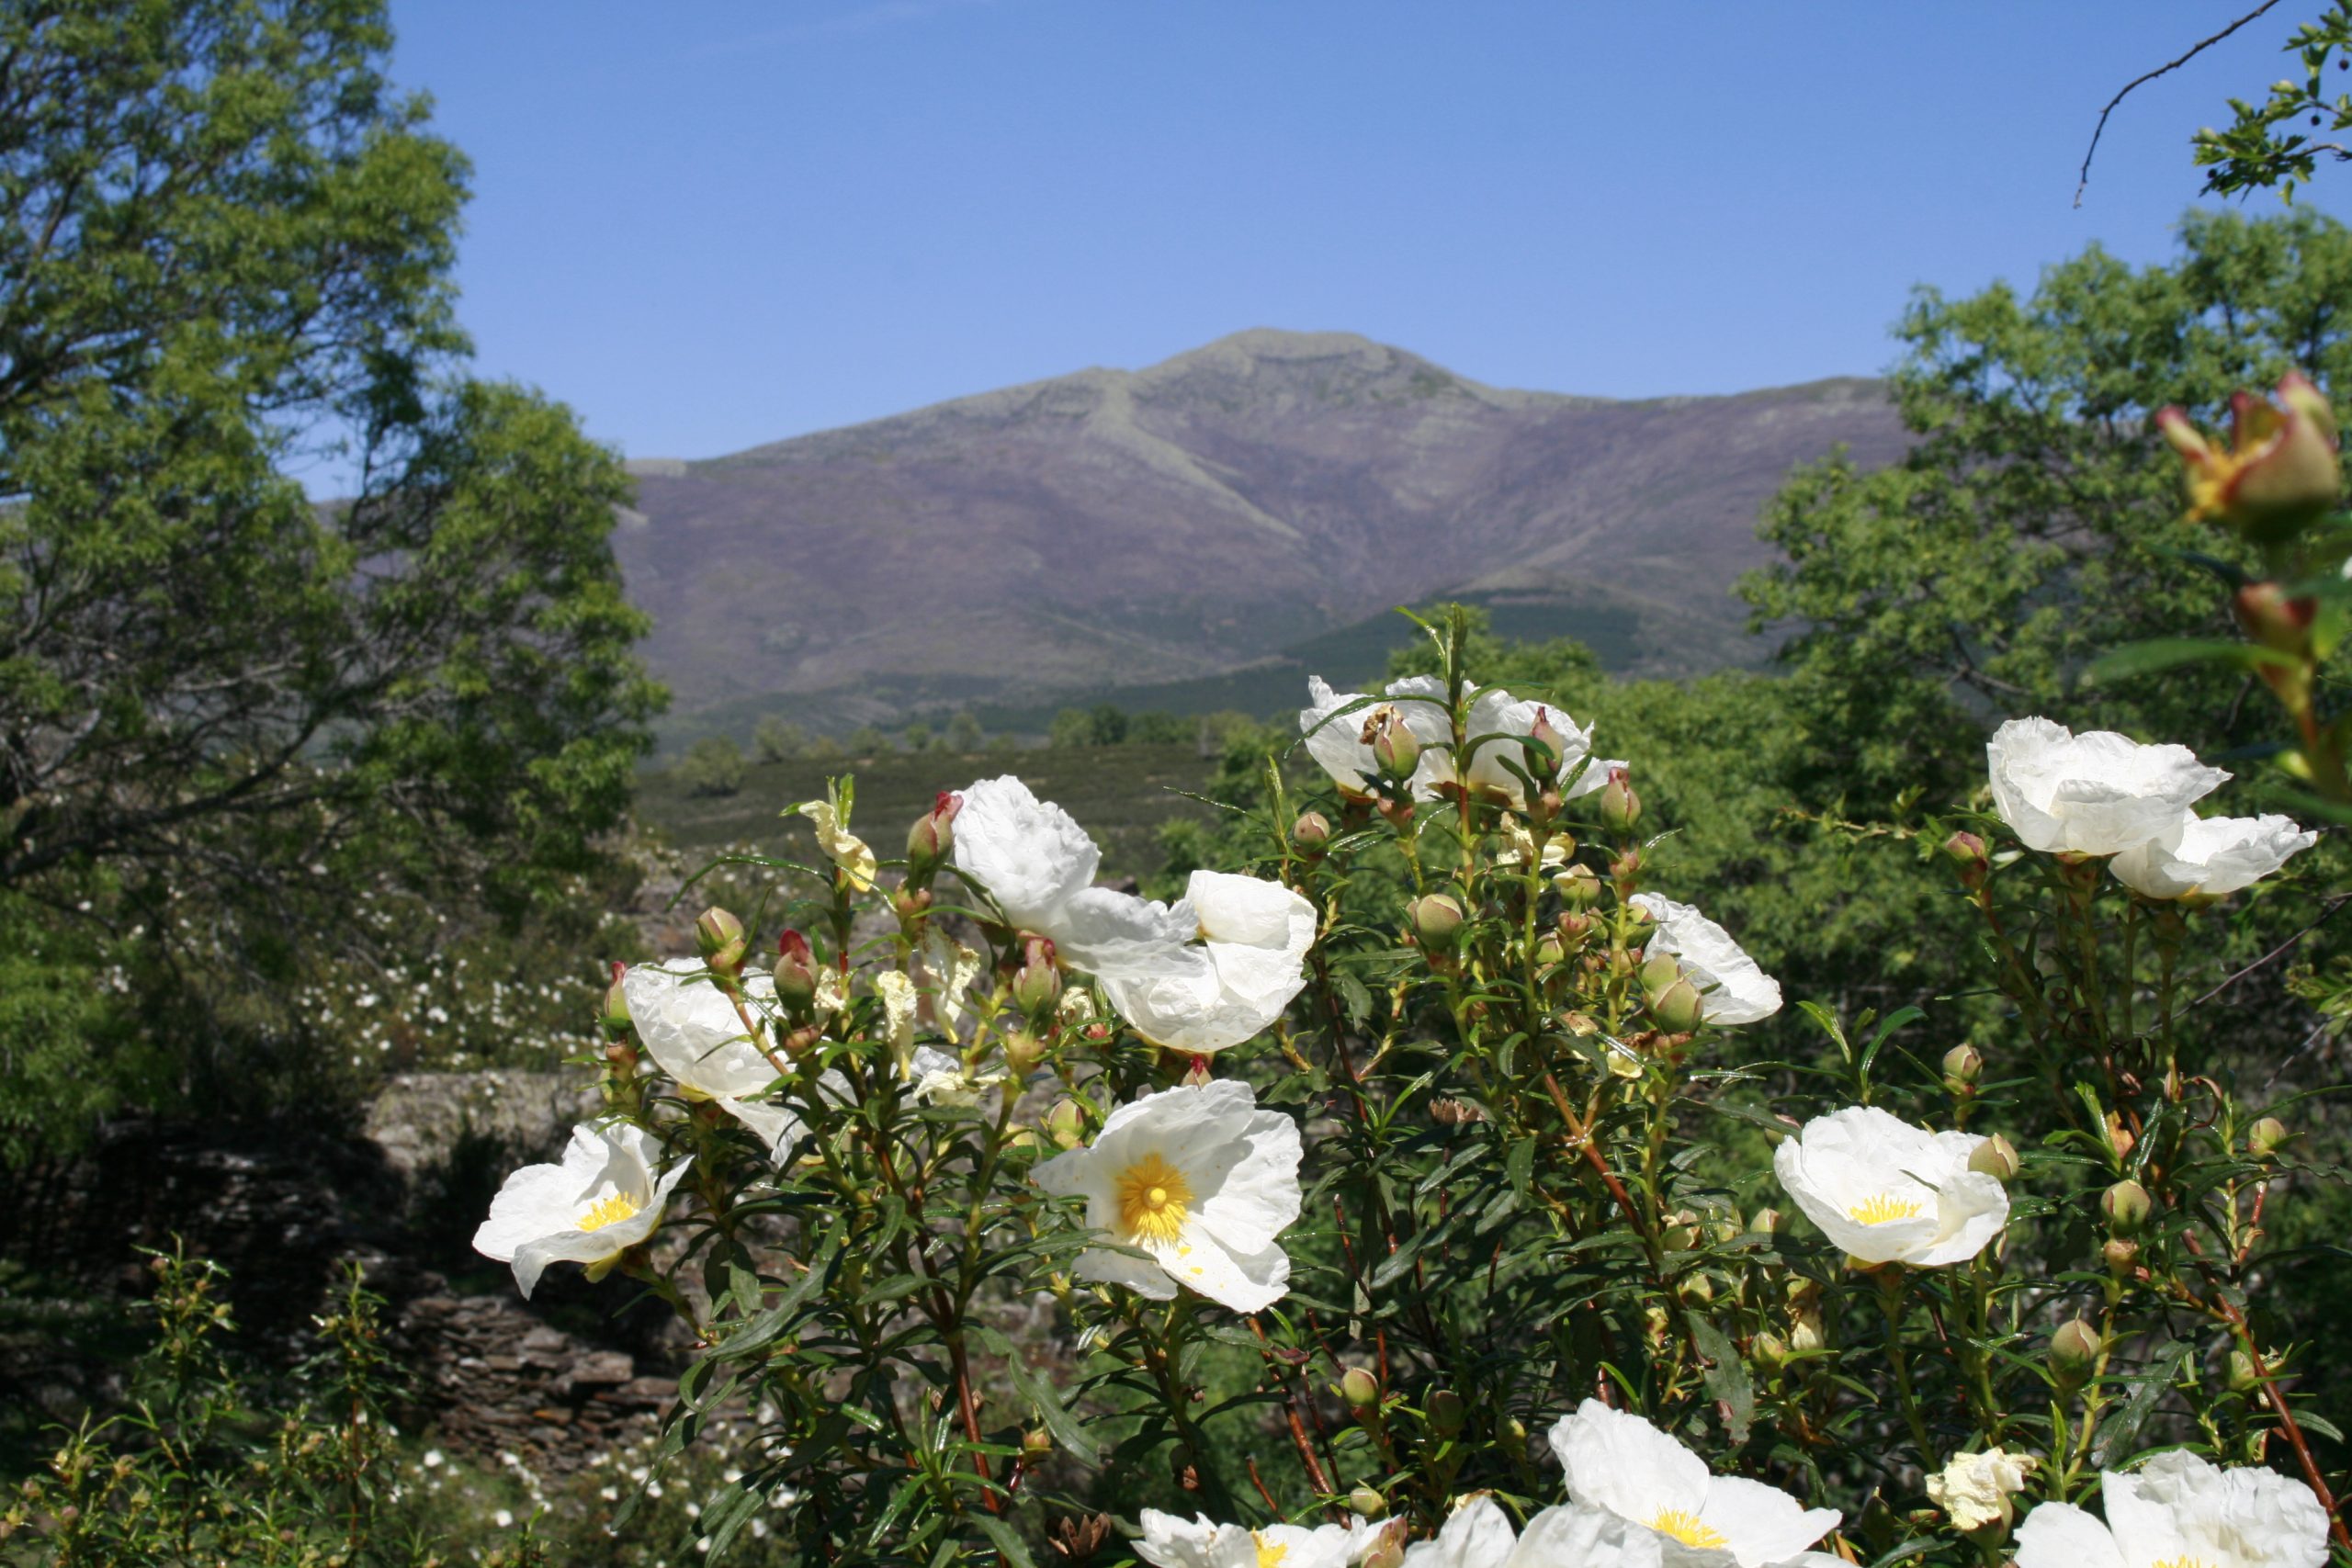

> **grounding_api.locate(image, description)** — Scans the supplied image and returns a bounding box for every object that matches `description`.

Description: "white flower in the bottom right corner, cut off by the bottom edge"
[2016,1450,2328,1568]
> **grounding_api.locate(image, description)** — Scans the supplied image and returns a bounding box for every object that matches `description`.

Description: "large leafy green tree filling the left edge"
[0,0,661,1143]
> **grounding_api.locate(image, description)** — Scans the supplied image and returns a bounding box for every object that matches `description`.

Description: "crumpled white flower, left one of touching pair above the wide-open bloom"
[948,773,1197,978]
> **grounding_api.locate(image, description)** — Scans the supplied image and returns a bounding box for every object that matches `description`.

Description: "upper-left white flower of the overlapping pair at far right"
[1985,719,2230,856]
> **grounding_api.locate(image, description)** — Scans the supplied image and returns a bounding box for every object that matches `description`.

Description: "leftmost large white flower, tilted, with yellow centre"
[473,1122,694,1300]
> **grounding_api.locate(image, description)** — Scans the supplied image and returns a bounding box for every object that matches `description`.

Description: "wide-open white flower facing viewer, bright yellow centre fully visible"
[1030,1079,1298,1312]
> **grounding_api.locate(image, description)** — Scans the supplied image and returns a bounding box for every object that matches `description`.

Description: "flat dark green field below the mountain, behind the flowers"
[638,745,1216,877]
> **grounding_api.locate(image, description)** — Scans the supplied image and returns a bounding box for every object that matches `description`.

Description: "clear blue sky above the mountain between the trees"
[393,0,2352,456]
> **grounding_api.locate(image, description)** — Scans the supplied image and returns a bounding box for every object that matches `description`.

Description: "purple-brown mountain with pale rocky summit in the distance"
[616,329,1903,728]
